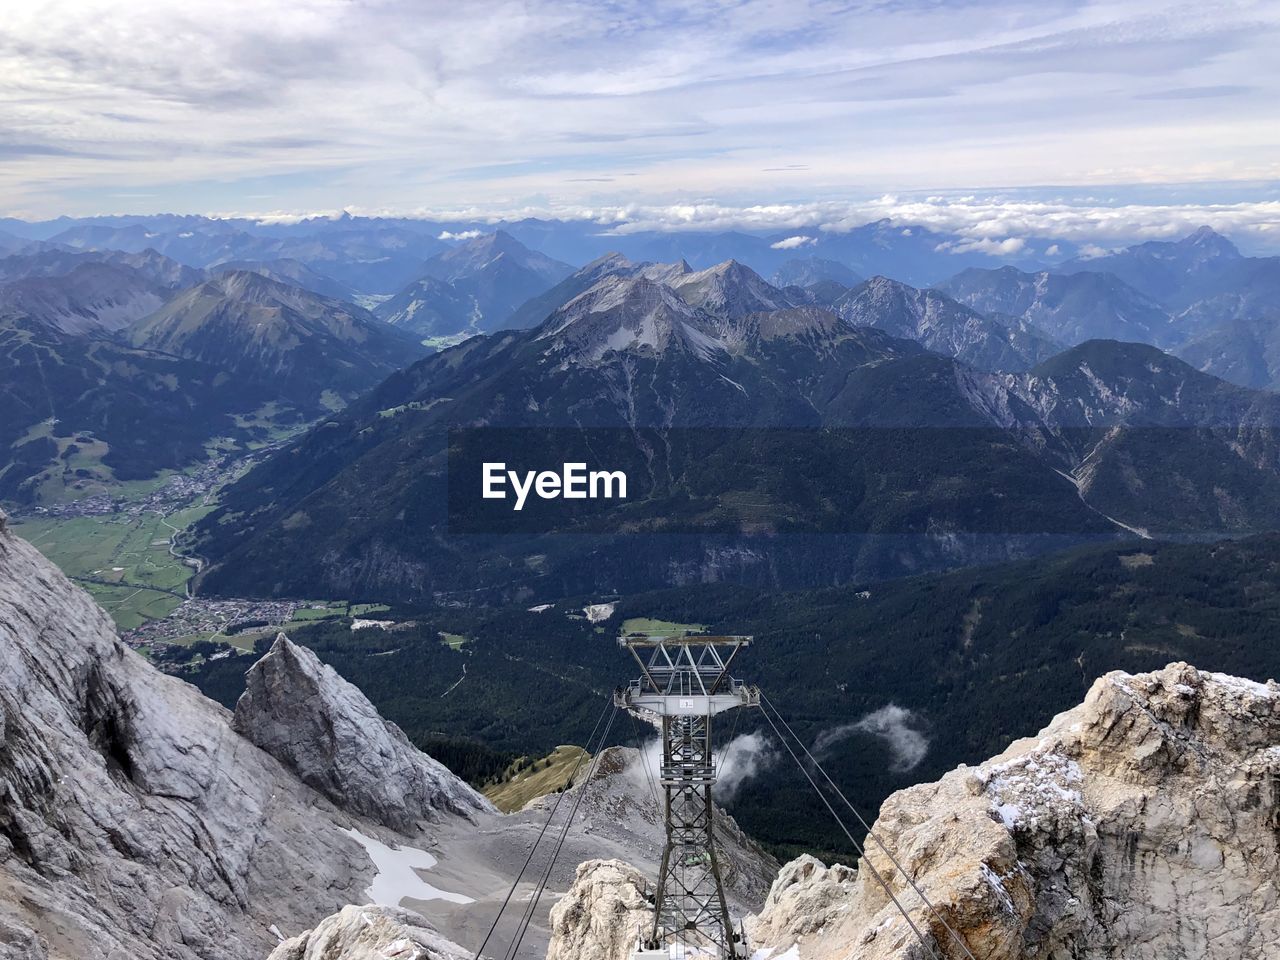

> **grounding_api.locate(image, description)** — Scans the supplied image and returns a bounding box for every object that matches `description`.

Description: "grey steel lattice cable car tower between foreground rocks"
[614,634,760,960]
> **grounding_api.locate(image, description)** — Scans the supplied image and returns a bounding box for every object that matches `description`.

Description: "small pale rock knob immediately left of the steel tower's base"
[547,860,653,960]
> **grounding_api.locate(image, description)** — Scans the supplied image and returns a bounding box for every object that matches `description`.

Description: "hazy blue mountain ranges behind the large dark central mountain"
[0,218,1280,542]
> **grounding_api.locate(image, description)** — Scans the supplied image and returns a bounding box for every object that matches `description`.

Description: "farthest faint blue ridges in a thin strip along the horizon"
[0,214,1076,296]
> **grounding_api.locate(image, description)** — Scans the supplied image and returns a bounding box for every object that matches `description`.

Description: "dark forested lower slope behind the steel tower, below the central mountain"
[188,535,1280,854]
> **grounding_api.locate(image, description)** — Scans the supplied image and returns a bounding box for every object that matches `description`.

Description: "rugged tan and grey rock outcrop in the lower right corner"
[750,663,1280,960]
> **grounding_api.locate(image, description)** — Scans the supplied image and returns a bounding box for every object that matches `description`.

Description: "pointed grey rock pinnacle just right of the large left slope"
[233,634,495,832]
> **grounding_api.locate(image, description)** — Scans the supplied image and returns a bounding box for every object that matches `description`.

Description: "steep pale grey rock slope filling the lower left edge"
[0,515,372,960]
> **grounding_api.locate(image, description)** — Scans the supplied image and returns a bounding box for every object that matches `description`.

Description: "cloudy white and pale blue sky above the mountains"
[0,0,1280,240]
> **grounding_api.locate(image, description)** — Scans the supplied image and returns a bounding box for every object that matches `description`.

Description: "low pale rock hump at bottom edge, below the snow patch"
[269,905,471,960]
